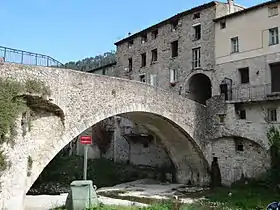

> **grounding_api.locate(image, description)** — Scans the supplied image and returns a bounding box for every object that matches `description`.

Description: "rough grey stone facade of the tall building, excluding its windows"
[116,4,220,92]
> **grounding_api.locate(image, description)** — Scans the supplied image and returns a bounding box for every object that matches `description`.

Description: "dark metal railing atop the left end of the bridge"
[0,46,63,67]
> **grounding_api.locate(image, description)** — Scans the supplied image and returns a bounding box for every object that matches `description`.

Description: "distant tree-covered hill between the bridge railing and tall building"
[64,51,116,71]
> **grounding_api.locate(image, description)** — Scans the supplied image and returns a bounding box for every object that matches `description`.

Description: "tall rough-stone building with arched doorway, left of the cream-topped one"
[115,1,243,103]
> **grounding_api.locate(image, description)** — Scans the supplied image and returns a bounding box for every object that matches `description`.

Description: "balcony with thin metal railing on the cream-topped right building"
[227,84,280,103]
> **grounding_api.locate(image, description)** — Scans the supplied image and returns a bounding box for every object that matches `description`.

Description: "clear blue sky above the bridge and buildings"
[0,0,267,63]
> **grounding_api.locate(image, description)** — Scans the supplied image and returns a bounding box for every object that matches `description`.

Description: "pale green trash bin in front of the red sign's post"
[71,180,98,210]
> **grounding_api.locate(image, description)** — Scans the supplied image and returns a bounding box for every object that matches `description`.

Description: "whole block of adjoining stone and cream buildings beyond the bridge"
[76,0,280,185]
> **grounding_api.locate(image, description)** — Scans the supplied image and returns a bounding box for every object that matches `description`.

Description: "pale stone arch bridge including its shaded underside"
[0,64,209,209]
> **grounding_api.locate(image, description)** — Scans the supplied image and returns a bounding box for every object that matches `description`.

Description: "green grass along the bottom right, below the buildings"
[50,184,280,210]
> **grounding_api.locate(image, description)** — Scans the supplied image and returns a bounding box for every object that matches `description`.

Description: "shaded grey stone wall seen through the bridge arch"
[76,117,171,167]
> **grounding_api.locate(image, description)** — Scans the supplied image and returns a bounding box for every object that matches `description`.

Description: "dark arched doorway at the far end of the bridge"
[188,73,212,104]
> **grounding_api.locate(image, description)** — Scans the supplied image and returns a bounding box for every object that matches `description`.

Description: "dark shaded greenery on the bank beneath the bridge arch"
[29,155,166,194]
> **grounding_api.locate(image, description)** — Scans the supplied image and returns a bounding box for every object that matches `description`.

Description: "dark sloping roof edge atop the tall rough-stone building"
[115,1,217,45]
